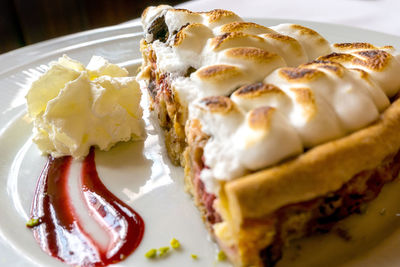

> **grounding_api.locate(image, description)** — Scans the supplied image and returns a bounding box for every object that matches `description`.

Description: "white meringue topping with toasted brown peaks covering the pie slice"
[140,5,400,188]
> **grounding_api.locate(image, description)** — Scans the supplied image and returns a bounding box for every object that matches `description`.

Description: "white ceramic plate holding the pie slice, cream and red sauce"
[0,19,400,267]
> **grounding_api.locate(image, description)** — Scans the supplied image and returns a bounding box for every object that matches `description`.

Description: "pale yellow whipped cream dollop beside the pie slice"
[26,55,144,158]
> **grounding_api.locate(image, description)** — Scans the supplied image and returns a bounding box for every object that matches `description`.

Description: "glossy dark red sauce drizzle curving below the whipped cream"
[31,148,145,266]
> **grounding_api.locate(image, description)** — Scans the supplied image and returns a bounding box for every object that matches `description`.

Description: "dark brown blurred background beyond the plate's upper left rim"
[0,0,184,53]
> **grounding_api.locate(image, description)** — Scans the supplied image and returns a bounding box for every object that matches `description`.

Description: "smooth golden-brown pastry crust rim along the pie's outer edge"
[222,96,400,230]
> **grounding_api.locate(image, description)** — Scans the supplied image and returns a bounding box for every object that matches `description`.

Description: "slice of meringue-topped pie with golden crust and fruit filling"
[138,6,400,266]
